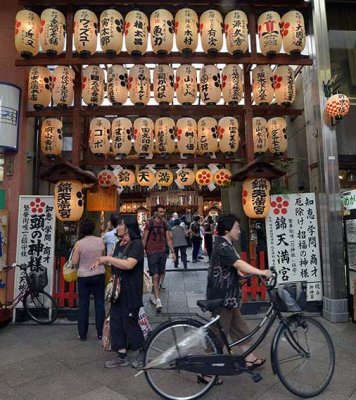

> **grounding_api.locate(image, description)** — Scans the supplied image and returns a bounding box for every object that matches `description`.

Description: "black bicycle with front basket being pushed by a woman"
[141,272,335,400]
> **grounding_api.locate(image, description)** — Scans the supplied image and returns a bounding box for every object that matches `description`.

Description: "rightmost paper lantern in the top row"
[281,10,306,54]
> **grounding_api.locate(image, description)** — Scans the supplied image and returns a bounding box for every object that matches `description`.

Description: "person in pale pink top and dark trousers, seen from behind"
[72,219,105,341]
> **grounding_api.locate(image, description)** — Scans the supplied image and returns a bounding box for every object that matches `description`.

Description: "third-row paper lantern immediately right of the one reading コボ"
[111,117,133,158]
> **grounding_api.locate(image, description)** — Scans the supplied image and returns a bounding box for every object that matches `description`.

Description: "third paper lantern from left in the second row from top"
[82,65,105,107]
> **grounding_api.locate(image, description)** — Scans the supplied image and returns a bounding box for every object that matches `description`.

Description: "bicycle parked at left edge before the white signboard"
[0,264,58,325]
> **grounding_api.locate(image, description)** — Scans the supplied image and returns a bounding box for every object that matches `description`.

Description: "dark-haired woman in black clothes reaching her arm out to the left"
[92,215,144,368]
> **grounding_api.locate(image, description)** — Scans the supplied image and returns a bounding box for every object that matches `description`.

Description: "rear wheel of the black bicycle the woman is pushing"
[144,320,222,400]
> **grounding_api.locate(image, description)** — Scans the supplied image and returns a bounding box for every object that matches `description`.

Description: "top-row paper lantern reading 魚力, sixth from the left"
[150,8,174,55]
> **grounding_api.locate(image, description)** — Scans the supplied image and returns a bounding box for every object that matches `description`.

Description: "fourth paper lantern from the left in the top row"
[100,8,124,56]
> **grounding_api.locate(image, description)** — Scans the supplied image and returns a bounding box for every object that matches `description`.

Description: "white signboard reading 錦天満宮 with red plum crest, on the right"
[266,193,322,301]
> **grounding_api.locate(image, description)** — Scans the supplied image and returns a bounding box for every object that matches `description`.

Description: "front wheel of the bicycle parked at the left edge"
[23,290,58,325]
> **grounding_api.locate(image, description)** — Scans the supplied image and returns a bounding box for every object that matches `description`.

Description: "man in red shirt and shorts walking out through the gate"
[142,204,175,312]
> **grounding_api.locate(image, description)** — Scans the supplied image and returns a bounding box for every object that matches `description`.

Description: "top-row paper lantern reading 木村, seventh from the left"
[175,8,199,55]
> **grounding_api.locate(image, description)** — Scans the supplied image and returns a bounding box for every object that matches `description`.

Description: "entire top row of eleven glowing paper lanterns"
[15,8,306,58]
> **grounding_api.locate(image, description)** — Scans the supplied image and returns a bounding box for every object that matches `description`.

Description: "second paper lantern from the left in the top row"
[40,8,66,56]
